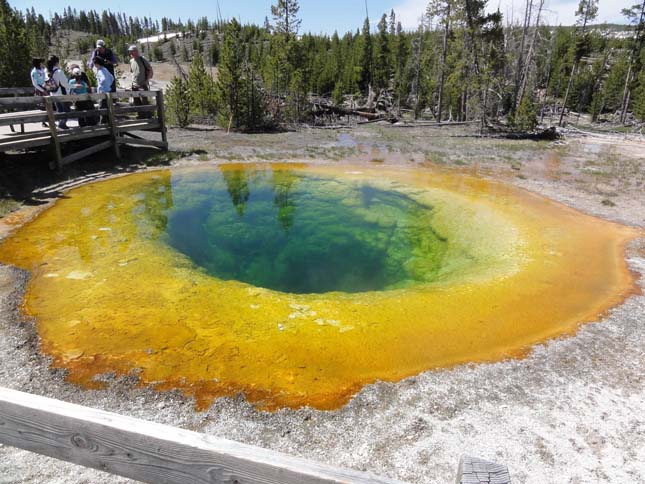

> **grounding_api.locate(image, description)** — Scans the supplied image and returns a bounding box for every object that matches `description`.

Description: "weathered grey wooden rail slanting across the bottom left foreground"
[0,388,397,484]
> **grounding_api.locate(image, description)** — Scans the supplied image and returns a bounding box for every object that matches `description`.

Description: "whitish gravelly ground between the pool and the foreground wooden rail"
[0,158,645,484]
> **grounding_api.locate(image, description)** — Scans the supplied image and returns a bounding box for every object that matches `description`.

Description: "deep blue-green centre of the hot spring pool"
[164,169,446,293]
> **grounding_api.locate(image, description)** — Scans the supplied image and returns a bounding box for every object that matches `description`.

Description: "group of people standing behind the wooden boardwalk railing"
[31,40,153,129]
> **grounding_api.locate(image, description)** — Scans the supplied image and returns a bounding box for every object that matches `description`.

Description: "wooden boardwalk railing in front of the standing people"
[0,88,168,170]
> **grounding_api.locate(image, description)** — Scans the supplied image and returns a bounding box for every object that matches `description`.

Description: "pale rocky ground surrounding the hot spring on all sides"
[0,125,645,484]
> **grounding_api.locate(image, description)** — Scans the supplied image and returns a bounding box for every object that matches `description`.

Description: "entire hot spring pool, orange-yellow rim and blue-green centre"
[0,164,638,409]
